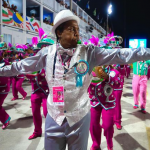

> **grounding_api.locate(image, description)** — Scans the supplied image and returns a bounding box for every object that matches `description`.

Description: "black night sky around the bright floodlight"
[74,0,150,47]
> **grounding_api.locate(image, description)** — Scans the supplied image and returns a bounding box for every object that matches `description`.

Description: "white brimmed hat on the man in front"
[52,10,80,34]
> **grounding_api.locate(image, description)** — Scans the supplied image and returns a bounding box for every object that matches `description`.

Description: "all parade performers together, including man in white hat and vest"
[0,10,150,150]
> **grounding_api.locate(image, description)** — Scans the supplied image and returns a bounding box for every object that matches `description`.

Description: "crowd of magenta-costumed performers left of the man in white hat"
[0,29,54,140]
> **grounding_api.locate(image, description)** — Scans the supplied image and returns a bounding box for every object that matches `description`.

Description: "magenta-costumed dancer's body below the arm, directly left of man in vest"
[26,69,48,140]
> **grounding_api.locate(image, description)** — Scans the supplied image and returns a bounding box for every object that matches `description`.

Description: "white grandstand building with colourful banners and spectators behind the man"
[0,0,106,44]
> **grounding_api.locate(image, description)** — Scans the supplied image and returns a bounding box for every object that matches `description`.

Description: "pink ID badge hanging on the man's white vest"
[52,86,64,106]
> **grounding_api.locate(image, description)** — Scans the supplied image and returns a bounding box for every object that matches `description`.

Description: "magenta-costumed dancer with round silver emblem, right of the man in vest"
[88,67,120,150]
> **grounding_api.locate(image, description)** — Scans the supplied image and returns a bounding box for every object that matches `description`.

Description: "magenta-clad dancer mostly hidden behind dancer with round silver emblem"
[114,65,126,130]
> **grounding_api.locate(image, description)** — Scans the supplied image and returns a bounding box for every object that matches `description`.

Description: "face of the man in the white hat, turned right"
[57,20,79,49]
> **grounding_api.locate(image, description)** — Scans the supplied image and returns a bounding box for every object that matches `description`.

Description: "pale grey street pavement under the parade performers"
[0,77,150,150]
